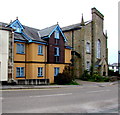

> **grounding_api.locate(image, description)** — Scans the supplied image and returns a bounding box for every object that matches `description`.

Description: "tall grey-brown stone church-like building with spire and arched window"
[62,8,108,77]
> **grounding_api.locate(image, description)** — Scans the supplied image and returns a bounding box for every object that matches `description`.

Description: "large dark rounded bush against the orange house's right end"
[55,67,75,85]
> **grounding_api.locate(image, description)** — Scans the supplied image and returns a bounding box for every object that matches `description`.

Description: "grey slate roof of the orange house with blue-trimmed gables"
[0,22,68,46]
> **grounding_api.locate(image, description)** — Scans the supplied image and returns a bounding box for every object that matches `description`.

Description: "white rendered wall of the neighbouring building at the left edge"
[0,30,9,81]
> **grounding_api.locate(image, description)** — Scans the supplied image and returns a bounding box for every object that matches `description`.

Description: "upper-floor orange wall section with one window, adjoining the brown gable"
[26,43,47,62]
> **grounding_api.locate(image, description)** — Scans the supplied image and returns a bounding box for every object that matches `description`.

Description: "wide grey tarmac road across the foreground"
[1,84,118,113]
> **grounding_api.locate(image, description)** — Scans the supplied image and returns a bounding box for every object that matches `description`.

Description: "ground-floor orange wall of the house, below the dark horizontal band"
[14,63,68,83]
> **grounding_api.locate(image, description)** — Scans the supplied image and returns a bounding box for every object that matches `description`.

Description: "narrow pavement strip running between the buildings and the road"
[0,80,118,90]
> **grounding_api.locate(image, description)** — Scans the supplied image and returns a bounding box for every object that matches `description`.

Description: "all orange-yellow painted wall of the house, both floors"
[14,43,71,83]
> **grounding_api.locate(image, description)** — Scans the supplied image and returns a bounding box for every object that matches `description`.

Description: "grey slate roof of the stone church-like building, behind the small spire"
[62,21,91,31]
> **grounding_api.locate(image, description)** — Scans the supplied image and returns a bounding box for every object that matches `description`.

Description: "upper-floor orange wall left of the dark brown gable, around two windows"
[14,42,47,62]
